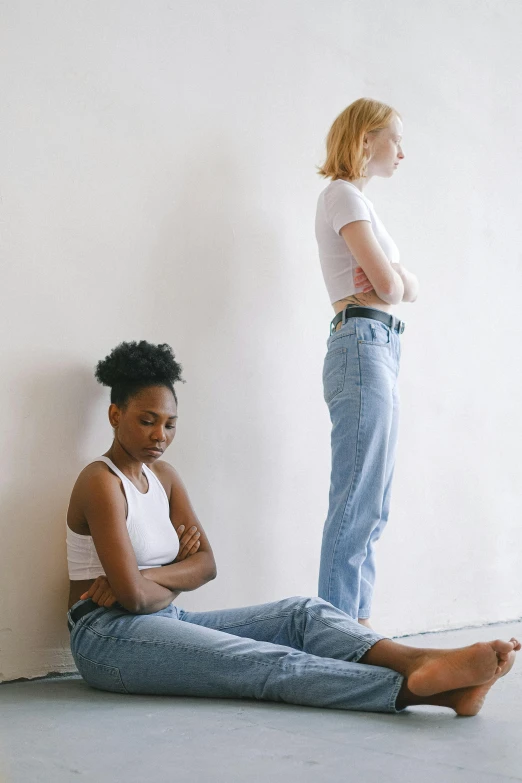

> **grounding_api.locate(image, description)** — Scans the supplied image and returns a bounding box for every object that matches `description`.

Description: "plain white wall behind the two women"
[0,0,522,679]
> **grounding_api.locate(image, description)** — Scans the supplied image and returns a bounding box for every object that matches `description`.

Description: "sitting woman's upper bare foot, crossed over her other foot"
[407,639,520,709]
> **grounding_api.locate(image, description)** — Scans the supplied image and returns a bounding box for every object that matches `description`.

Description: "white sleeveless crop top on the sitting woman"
[67,457,179,580]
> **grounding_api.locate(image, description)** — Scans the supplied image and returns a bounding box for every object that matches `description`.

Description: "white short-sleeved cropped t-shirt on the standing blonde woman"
[315,179,399,304]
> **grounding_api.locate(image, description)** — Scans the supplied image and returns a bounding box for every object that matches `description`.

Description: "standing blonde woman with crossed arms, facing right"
[316,98,418,625]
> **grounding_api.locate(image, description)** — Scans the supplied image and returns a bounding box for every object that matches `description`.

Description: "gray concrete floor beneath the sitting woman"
[0,622,522,783]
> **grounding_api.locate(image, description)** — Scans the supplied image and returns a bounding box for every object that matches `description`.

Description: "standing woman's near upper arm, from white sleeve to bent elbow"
[341,220,404,305]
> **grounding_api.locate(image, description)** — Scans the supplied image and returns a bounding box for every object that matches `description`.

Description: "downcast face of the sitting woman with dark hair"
[109,386,178,465]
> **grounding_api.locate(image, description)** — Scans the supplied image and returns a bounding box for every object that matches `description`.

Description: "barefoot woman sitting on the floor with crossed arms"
[67,341,520,715]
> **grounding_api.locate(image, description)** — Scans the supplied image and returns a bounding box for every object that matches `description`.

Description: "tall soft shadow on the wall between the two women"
[142,138,283,604]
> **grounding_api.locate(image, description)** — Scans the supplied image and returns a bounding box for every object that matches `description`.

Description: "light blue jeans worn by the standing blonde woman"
[319,318,401,618]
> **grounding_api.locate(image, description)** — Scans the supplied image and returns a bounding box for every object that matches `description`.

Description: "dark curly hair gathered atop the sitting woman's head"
[94,340,183,407]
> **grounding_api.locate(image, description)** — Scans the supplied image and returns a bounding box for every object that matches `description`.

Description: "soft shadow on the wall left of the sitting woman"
[0,360,100,679]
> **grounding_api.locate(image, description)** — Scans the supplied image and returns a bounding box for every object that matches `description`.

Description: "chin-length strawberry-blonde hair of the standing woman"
[319,98,400,180]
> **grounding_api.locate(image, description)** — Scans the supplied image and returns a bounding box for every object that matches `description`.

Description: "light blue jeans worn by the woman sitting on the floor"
[69,598,403,712]
